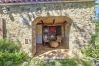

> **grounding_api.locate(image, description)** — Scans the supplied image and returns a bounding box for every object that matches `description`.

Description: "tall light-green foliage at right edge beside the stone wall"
[82,20,99,60]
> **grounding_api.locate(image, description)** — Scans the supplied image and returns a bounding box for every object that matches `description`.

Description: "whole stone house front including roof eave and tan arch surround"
[0,0,95,56]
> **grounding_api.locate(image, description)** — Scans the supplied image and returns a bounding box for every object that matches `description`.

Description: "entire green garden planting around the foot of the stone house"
[0,20,99,66]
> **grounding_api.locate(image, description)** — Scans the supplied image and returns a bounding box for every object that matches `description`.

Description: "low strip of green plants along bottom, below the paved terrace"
[31,58,91,66]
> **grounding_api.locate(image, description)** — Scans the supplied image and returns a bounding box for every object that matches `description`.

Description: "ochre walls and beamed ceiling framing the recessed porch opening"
[32,16,72,55]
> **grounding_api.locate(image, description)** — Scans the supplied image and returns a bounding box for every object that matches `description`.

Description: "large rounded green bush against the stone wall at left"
[0,39,28,66]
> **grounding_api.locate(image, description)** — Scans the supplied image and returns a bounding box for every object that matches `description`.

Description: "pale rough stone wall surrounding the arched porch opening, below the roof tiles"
[0,2,95,55]
